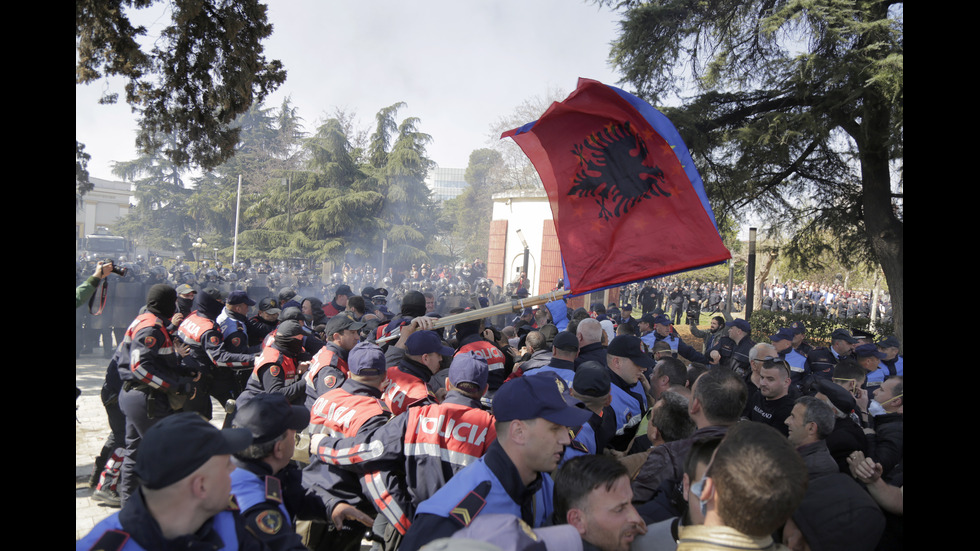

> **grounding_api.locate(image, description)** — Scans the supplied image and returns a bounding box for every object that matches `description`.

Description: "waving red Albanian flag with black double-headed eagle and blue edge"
[500,78,731,294]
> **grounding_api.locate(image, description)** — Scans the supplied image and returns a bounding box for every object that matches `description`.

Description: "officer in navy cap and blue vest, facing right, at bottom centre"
[399,374,592,551]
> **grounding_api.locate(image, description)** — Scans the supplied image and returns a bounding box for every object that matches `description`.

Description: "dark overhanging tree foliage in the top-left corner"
[75,0,286,169]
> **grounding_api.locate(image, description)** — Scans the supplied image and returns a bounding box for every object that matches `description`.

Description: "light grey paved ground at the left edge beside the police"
[75,350,225,541]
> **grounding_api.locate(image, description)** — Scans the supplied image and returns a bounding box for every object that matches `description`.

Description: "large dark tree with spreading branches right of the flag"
[600,0,904,337]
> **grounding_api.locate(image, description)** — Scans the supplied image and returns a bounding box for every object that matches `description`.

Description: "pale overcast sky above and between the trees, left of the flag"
[75,0,619,179]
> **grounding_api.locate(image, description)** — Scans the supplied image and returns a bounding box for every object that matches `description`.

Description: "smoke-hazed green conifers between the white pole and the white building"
[240,103,435,265]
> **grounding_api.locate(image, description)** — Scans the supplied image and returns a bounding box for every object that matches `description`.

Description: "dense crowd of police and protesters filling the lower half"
[76,262,904,551]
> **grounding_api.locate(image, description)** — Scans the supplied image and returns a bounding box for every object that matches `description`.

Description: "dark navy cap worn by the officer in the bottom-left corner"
[136,412,252,490]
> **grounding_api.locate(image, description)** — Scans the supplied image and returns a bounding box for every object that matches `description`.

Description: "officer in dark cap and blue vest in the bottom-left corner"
[75,412,267,551]
